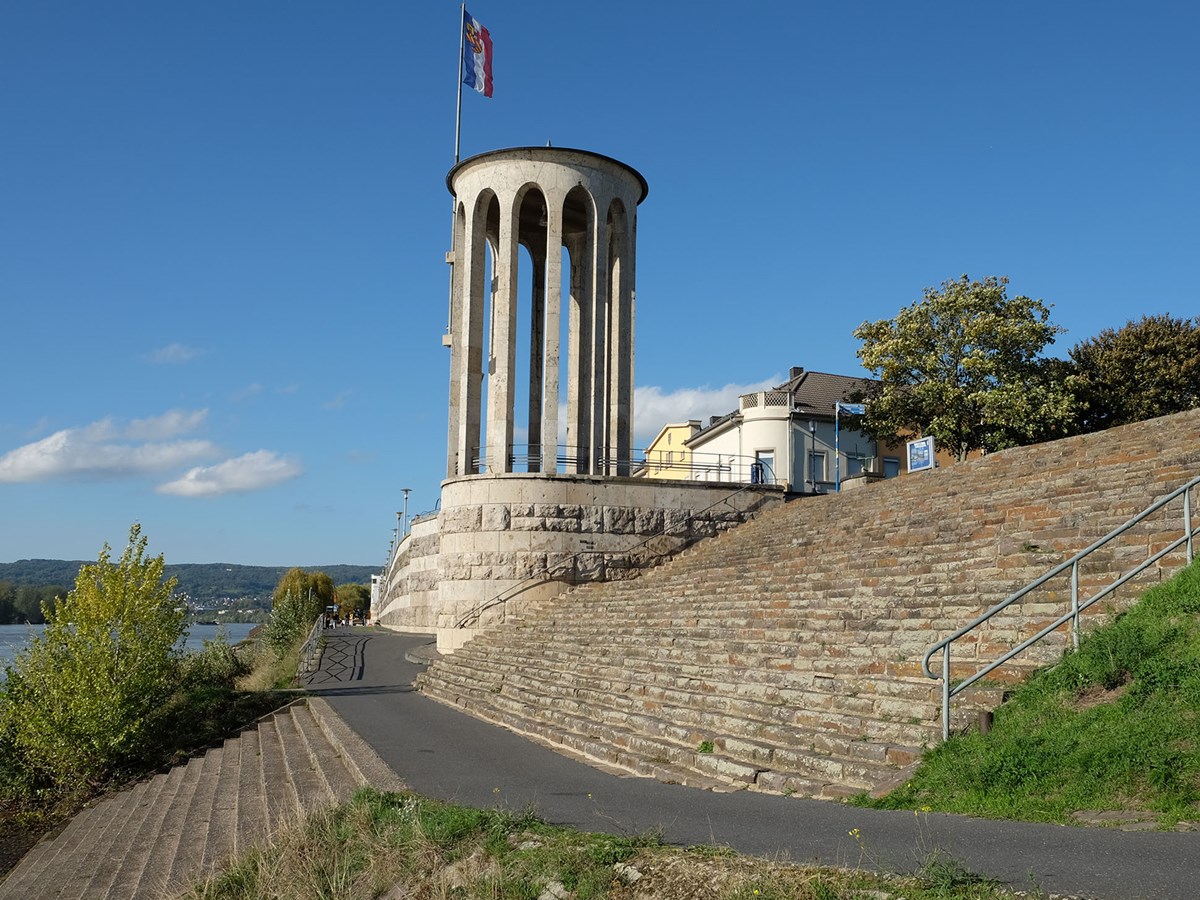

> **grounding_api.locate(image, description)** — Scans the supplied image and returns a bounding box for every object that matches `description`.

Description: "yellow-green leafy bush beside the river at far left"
[0,524,184,787]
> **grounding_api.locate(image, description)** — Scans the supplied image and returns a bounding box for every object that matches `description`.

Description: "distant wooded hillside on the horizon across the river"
[0,559,379,600]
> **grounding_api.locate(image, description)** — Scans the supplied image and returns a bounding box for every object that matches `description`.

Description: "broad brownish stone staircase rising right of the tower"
[419,410,1200,798]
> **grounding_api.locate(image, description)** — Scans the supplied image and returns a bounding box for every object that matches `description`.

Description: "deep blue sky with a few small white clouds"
[0,0,1200,565]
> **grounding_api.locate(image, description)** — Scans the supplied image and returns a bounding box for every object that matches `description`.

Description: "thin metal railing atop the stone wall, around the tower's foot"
[460,444,780,485]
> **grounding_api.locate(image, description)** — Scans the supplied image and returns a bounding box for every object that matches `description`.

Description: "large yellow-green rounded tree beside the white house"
[853,275,1074,460]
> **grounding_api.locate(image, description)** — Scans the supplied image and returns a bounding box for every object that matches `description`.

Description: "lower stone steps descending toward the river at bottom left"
[0,698,401,900]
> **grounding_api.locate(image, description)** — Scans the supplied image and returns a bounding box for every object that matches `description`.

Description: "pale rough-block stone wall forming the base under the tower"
[374,473,784,652]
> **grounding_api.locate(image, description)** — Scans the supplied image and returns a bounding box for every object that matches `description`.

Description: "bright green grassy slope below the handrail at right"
[857,563,1200,827]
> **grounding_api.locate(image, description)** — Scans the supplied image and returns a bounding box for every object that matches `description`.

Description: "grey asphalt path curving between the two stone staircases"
[312,629,1200,900]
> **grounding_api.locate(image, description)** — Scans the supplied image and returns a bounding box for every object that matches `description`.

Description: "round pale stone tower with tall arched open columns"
[446,146,648,478]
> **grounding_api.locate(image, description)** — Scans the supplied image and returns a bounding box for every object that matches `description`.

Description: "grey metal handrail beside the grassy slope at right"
[920,476,1200,740]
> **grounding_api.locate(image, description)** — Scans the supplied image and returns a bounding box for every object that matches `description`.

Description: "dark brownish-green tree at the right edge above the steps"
[1069,313,1200,432]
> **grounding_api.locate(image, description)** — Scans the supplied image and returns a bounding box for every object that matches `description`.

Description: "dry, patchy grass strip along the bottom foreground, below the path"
[187,788,1013,900]
